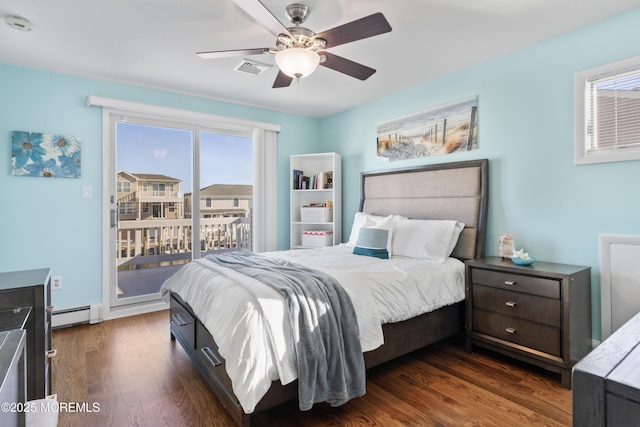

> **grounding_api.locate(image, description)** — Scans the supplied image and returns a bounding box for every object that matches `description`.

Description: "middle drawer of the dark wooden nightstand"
[473,285,560,327]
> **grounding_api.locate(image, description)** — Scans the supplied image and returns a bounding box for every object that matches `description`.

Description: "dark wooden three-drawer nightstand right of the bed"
[465,257,592,389]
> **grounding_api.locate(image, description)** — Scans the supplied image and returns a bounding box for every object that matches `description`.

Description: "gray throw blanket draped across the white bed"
[206,251,366,411]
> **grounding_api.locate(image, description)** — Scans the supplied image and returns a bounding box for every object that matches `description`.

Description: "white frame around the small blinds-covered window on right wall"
[574,56,640,165]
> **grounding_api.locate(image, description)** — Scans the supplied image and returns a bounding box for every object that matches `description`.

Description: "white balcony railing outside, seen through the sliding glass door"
[116,218,251,268]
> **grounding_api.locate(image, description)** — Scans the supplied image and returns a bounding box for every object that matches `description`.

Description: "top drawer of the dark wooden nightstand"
[471,269,560,299]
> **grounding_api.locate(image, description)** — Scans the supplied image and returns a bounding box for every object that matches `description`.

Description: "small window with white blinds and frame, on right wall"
[575,57,640,164]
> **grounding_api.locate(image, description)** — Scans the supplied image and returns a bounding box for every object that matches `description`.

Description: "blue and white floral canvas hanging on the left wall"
[11,131,81,178]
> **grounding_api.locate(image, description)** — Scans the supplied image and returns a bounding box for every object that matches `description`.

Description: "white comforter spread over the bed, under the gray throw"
[160,245,464,414]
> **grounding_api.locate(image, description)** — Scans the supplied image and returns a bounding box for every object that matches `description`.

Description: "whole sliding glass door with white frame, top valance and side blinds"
[86,95,280,319]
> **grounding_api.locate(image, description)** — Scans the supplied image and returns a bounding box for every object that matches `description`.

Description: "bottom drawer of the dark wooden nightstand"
[473,309,562,357]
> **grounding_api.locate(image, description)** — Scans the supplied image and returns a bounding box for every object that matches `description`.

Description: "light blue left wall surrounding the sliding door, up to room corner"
[0,64,318,309]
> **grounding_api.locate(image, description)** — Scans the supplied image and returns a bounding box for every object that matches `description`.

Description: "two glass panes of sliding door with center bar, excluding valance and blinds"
[110,118,253,306]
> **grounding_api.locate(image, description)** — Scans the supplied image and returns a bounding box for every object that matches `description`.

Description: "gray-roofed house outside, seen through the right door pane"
[184,184,253,218]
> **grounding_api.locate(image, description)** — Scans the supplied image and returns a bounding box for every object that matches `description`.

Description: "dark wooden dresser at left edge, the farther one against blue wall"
[0,268,56,400]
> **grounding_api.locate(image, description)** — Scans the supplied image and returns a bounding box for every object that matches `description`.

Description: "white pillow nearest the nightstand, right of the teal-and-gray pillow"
[392,219,464,263]
